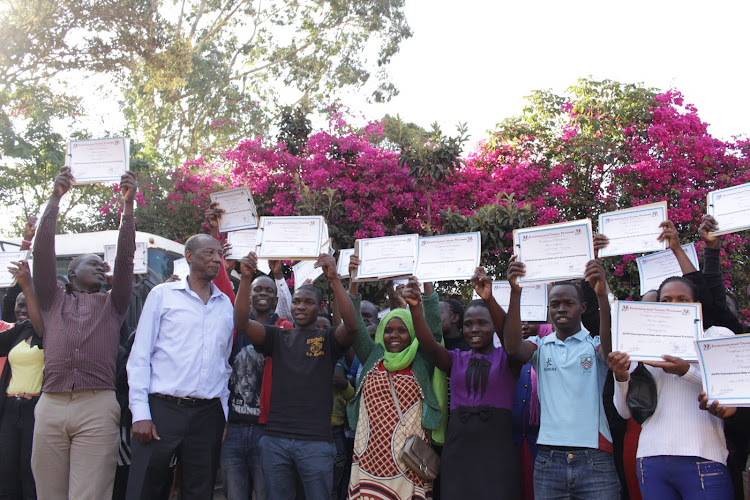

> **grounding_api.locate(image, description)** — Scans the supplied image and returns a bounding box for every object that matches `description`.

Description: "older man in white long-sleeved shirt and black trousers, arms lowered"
[127,234,233,499]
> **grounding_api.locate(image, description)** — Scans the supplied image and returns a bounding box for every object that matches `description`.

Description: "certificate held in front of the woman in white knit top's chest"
[612,301,703,361]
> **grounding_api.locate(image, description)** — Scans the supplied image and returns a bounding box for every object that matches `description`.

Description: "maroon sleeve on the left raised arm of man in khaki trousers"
[31,204,61,311]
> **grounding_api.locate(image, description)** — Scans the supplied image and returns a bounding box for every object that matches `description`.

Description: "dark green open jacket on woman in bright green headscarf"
[346,292,443,430]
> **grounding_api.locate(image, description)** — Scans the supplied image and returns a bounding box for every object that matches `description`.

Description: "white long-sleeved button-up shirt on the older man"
[127,277,234,422]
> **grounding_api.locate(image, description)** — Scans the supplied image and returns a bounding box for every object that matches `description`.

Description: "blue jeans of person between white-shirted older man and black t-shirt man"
[221,424,266,500]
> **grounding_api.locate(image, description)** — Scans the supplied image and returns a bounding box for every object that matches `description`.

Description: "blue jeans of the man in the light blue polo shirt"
[534,446,620,500]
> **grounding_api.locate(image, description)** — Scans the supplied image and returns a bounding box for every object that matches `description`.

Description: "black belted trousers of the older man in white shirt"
[126,395,225,500]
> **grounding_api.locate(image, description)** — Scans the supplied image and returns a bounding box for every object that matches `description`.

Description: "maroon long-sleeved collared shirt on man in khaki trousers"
[33,205,135,392]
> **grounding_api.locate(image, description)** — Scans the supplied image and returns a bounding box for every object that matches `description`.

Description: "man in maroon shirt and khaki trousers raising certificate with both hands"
[31,168,137,500]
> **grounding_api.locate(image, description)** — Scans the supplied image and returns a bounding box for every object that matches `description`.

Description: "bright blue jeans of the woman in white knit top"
[637,456,734,500]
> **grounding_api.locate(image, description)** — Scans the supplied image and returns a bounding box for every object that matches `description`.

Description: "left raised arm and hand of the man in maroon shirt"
[33,167,73,311]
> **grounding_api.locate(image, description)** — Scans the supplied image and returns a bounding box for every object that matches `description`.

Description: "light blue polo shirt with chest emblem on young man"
[527,327,612,451]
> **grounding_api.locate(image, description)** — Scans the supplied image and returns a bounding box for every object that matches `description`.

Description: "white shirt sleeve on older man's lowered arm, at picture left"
[126,285,164,422]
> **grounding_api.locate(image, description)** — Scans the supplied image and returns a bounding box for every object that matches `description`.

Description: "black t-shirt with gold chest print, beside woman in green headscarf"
[259,326,344,441]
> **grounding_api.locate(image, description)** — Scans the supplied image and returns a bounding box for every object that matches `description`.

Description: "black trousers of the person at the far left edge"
[0,396,39,500]
